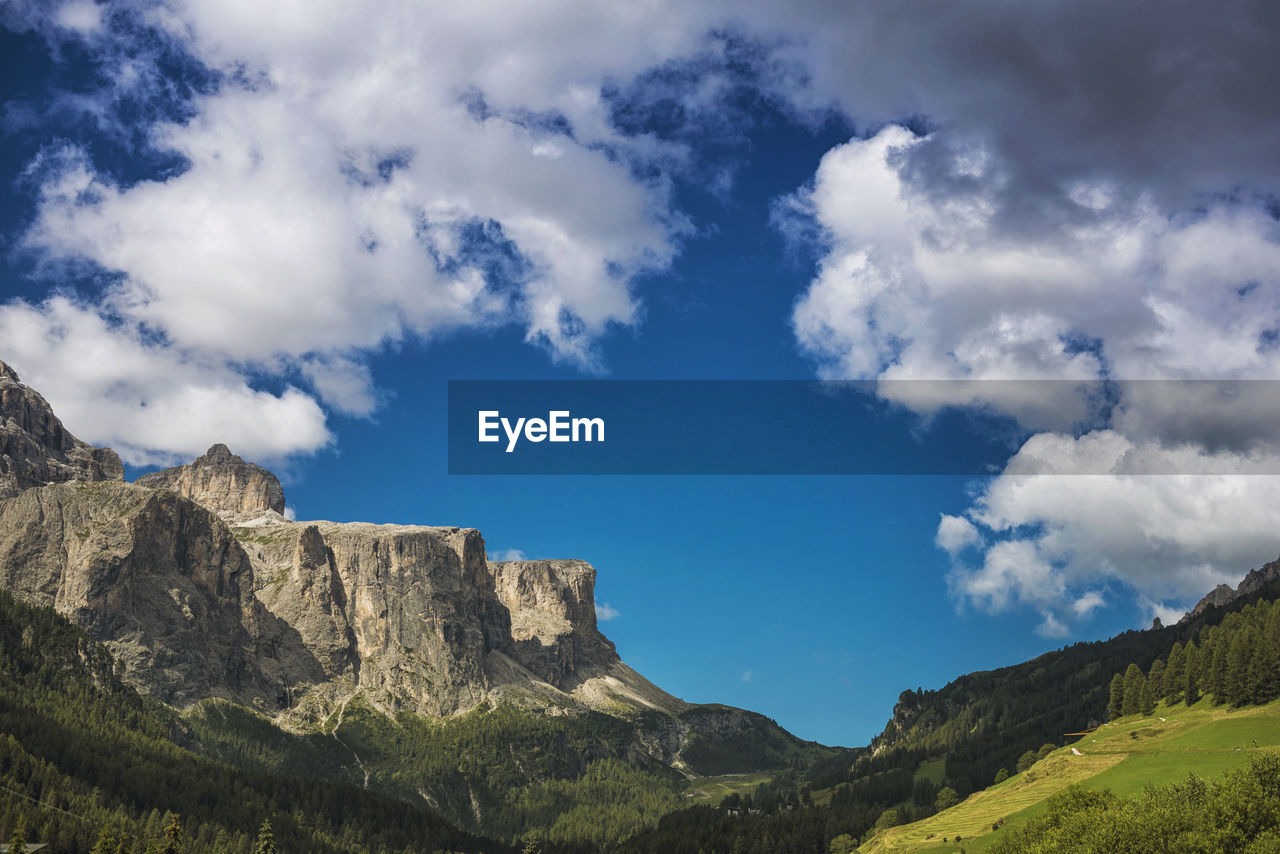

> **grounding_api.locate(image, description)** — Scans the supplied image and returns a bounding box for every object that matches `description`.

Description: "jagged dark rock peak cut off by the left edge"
[0,362,124,498]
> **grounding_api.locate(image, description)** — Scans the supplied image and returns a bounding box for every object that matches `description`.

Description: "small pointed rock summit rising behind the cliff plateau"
[137,444,284,519]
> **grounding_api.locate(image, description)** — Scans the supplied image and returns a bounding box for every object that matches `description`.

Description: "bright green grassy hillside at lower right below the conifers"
[859,700,1280,854]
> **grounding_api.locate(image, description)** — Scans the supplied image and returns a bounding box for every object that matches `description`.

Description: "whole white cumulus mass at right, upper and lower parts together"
[787,125,1280,636]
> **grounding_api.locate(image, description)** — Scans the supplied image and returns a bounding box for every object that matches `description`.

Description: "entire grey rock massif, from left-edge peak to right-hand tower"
[0,369,687,721]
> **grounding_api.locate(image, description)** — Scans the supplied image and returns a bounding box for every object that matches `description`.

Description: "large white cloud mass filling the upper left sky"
[0,0,737,462]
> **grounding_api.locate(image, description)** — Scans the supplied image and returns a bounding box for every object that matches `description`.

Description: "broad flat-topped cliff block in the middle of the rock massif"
[236,522,504,716]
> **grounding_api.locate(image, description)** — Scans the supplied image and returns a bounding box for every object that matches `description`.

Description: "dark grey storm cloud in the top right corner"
[765,0,1280,214]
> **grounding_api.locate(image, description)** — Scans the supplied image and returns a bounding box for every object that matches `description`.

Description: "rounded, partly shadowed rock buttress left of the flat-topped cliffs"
[0,483,323,711]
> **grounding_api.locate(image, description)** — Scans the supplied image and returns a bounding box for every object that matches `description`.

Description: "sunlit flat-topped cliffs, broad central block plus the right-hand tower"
[233,520,686,716]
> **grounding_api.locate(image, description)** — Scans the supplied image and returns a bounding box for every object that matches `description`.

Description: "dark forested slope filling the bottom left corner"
[0,592,508,854]
